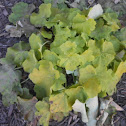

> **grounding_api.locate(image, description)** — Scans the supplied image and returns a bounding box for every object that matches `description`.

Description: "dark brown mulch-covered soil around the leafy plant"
[0,0,126,126]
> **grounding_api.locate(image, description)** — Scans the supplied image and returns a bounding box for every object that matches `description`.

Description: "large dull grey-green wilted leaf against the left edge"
[0,64,23,106]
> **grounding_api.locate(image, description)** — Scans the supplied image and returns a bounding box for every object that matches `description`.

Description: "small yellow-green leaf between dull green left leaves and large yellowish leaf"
[22,50,38,73]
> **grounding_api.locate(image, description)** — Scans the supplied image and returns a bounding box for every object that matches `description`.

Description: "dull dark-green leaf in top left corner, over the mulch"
[9,2,35,24]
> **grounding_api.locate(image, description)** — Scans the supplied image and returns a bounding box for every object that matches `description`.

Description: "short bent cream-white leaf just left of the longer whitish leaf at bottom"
[72,99,88,122]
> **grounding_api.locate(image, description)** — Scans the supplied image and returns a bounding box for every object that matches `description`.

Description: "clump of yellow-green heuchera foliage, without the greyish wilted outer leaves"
[0,1,126,126]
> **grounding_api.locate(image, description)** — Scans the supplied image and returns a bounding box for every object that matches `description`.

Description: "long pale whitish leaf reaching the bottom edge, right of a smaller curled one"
[86,96,98,126]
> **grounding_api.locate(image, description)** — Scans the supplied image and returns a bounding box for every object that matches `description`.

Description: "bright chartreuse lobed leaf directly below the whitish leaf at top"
[72,14,96,35]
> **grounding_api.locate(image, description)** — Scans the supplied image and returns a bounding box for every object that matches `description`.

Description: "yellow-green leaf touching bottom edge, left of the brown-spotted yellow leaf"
[35,98,51,126]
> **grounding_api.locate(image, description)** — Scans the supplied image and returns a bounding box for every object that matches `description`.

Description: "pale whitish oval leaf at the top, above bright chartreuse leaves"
[88,4,103,19]
